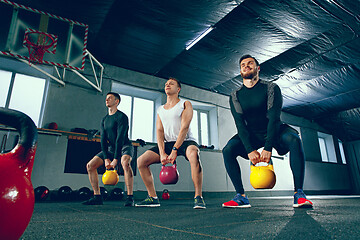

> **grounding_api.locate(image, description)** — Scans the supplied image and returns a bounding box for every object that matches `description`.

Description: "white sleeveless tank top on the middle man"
[157,99,196,142]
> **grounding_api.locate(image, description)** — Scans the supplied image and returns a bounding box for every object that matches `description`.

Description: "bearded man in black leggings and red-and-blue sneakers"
[222,55,312,208]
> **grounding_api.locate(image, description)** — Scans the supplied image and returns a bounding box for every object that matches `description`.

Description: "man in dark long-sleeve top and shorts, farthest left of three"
[83,92,134,206]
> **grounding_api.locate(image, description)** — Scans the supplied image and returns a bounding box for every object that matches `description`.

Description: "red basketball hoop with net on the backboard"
[24,30,55,64]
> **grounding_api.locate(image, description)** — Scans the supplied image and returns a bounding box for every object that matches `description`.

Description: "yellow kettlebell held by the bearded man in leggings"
[250,160,276,189]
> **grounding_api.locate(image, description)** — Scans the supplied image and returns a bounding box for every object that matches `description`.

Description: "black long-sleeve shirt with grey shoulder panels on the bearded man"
[230,80,283,153]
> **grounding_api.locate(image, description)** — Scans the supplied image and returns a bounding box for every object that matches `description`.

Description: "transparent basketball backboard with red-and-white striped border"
[0,0,88,70]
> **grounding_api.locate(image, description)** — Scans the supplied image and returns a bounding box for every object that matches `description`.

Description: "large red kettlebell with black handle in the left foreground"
[0,108,37,239]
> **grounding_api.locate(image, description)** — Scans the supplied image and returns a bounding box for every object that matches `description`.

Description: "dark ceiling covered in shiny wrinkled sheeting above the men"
[3,0,360,141]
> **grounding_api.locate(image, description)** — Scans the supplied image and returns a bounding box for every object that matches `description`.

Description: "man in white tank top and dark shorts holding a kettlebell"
[135,78,206,209]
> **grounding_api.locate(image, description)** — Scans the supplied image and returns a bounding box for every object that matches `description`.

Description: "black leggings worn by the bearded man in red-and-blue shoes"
[222,126,305,194]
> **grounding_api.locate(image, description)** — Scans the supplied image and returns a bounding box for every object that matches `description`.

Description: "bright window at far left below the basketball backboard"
[0,70,46,126]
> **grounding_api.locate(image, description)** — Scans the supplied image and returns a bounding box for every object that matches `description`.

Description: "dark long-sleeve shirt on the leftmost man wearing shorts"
[100,111,131,159]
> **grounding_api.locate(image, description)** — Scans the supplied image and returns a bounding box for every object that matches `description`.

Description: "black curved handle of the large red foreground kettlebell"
[0,108,38,149]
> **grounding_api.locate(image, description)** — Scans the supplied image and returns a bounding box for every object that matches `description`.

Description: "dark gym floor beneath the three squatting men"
[21,196,360,240]
